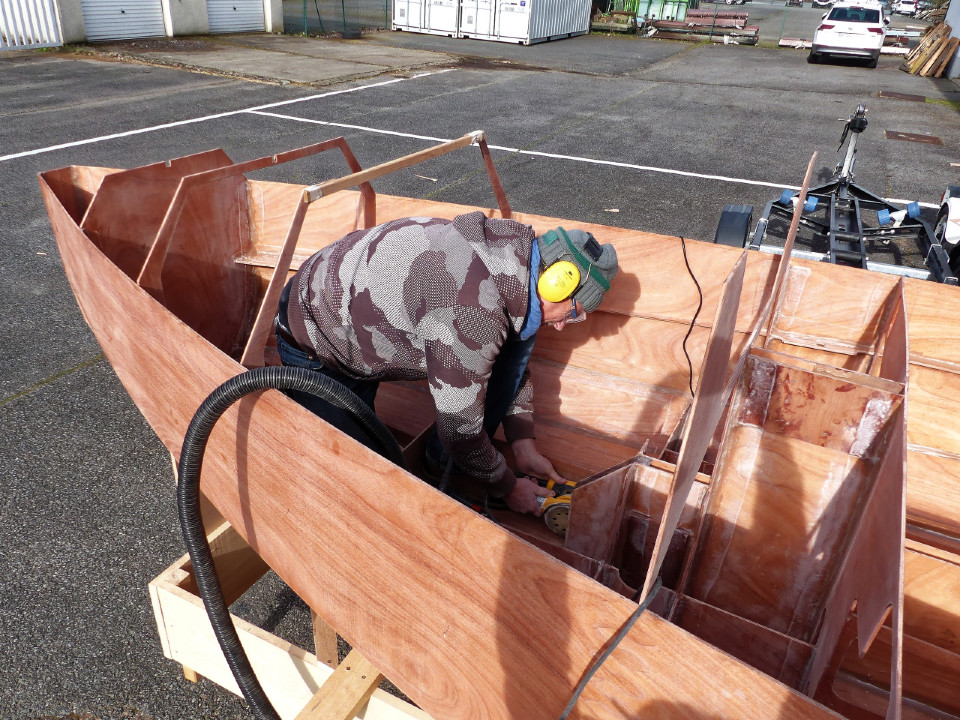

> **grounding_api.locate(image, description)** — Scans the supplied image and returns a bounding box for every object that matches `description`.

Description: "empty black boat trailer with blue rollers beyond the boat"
[714,104,960,285]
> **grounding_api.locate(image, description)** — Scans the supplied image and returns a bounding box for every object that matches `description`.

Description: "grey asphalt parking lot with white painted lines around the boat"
[0,19,960,720]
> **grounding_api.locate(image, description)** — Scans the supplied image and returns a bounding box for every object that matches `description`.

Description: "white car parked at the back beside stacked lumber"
[807,0,890,67]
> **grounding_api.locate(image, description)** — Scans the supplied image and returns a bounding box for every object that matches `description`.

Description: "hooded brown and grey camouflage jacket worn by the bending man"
[287,212,535,495]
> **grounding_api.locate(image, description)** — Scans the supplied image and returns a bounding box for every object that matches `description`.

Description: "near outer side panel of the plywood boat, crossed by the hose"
[44,177,848,720]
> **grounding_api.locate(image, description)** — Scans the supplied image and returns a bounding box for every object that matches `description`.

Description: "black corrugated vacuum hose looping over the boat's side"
[177,367,403,720]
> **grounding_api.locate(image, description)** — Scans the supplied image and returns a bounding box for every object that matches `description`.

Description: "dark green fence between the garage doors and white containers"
[283,0,391,38]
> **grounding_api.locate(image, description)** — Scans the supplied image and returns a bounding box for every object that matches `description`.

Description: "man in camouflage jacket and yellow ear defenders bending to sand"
[275,212,618,514]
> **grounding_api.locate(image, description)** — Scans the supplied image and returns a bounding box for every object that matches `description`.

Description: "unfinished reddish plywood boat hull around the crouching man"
[40,136,960,719]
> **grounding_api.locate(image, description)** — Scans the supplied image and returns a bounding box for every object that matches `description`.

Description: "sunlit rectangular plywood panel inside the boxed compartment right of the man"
[684,425,866,642]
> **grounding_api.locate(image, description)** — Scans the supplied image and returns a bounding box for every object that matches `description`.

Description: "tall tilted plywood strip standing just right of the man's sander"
[641,252,746,598]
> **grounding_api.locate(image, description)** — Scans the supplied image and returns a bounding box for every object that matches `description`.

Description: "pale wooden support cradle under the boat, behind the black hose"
[150,522,430,720]
